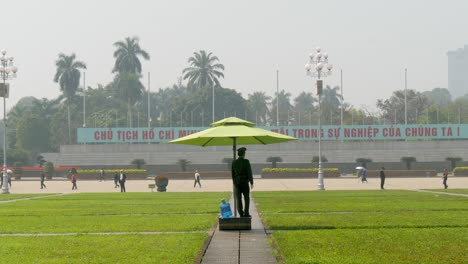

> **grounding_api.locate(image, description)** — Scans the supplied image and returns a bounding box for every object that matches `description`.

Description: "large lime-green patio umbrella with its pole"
[169,117,297,215]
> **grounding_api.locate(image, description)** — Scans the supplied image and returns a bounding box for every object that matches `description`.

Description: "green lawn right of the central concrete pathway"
[255,190,468,263]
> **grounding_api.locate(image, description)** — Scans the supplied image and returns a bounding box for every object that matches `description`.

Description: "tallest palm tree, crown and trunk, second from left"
[112,37,150,127]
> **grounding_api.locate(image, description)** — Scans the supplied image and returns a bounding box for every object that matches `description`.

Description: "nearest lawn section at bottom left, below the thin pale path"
[0,233,208,264]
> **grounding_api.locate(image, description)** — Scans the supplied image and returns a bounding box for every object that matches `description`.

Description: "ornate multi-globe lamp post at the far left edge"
[0,49,18,194]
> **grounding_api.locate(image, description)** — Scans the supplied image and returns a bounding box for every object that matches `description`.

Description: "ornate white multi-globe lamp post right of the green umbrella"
[305,47,333,190]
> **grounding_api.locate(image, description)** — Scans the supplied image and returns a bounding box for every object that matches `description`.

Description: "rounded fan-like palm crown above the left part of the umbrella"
[182,50,224,88]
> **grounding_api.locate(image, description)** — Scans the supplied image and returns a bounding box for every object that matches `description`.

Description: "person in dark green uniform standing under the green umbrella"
[231,147,253,217]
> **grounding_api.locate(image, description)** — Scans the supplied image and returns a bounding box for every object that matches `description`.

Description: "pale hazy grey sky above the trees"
[0,0,468,110]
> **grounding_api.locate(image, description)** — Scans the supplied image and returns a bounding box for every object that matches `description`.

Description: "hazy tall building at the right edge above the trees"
[447,45,468,99]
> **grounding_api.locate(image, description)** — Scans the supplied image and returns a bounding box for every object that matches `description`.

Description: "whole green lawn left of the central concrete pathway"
[0,193,230,263]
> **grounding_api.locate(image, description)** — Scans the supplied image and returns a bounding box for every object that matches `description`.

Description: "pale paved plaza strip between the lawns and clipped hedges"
[4,177,468,193]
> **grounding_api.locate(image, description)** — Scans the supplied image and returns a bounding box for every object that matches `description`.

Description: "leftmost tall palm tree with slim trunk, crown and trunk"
[54,53,86,143]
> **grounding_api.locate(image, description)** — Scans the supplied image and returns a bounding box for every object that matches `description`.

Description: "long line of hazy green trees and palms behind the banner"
[0,37,468,165]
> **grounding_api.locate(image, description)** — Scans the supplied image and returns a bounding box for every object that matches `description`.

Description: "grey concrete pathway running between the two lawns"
[201,199,277,264]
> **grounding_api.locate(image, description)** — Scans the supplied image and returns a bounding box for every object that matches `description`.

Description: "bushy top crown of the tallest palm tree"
[112,37,150,74]
